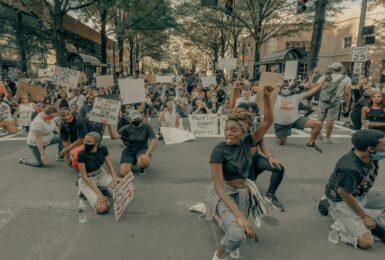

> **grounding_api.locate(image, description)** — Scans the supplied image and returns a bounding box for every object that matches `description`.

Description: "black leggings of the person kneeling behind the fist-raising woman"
[250,154,285,194]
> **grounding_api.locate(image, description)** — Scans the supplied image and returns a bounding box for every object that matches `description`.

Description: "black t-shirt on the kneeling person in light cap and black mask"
[119,123,155,153]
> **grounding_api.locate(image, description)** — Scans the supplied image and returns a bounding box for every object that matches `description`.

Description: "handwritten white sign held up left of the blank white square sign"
[89,97,121,125]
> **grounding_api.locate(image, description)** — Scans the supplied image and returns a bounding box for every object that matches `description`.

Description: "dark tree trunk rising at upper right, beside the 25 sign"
[307,0,328,74]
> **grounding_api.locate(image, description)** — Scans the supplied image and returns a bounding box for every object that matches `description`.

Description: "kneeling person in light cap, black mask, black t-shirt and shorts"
[108,110,158,177]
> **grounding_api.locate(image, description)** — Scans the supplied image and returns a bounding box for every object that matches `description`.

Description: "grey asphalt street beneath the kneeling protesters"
[0,118,385,260]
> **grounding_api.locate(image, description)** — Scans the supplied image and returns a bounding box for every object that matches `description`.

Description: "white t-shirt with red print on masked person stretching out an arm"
[274,93,305,125]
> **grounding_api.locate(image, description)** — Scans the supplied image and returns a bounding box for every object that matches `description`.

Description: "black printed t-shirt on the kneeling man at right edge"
[325,149,378,202]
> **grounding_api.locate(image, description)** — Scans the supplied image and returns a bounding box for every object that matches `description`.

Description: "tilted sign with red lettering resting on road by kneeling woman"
[112,173,134,221]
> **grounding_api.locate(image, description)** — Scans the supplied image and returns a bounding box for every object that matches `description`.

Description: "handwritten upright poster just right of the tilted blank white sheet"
[188,114,218,137]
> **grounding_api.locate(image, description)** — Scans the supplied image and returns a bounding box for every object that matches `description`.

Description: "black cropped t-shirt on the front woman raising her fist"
[210,135,253,181]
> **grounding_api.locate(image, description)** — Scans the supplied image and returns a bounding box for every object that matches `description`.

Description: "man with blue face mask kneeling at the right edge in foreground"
[325,129,385,249]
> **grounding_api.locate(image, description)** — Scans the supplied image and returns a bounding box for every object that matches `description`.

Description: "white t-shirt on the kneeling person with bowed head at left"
[27,113,56,146]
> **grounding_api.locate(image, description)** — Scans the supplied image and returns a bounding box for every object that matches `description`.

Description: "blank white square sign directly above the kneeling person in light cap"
[118,79,146,105]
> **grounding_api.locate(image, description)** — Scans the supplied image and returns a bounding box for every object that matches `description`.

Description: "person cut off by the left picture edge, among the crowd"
[0,85,19,134]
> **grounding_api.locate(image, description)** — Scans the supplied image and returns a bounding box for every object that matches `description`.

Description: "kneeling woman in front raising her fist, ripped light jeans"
[205,87,274,260]
